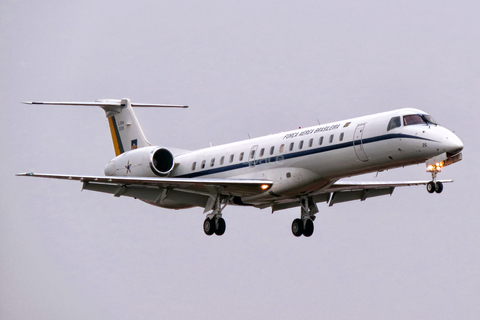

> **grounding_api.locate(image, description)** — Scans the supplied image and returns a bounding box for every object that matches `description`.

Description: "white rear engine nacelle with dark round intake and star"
[105,147,175,177]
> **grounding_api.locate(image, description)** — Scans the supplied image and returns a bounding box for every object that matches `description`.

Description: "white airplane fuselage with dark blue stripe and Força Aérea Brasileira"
[105,109,462,208]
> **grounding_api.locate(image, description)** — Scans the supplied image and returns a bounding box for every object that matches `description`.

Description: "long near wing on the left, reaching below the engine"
[16,173,273,206]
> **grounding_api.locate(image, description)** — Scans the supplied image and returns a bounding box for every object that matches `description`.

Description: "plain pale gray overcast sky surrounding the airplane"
[0,0,480,319]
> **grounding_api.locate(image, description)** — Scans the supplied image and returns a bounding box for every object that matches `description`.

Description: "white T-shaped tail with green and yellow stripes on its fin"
[23,99,188,156]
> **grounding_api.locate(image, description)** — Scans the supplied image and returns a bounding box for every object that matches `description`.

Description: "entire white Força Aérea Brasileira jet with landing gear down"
[17,99,463,237]
